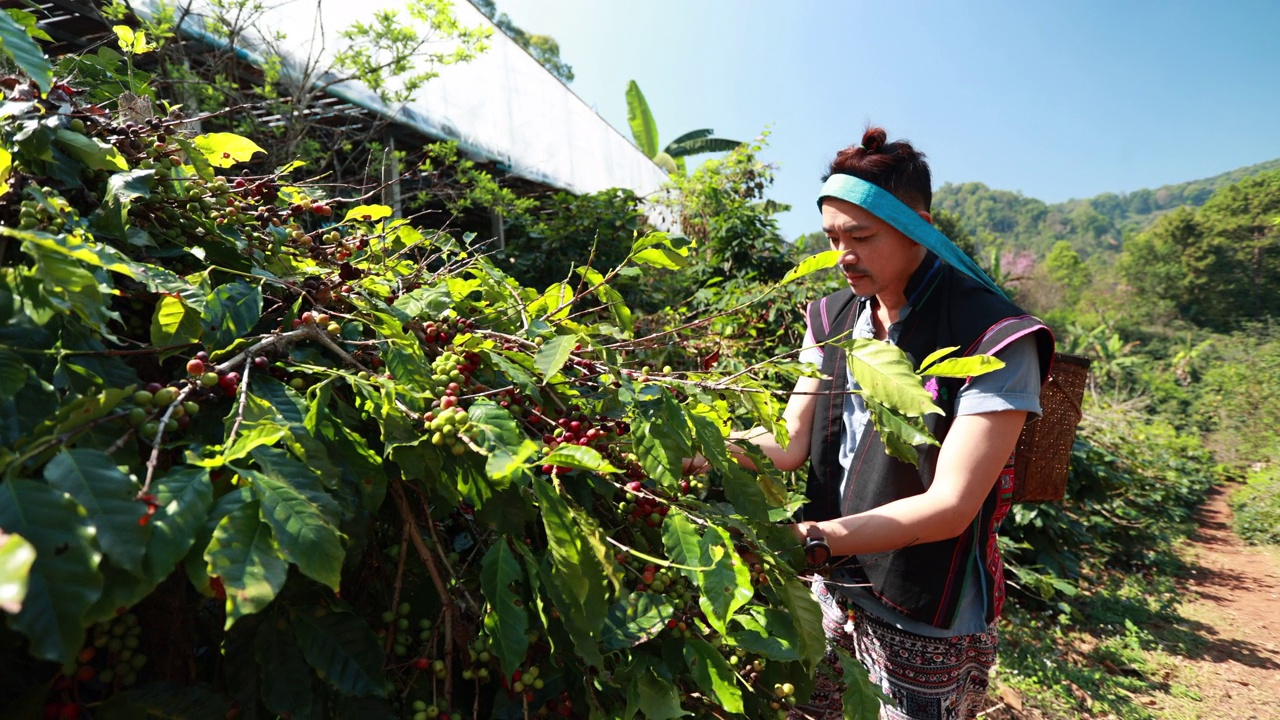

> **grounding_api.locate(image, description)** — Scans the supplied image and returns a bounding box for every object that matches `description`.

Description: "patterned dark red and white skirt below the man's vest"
[790,579,997,720]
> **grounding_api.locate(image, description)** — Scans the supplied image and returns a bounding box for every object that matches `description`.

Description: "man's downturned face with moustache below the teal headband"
[822,197,929,300]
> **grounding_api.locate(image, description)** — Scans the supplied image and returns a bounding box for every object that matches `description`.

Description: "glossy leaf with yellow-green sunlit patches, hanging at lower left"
[205,500,289,629]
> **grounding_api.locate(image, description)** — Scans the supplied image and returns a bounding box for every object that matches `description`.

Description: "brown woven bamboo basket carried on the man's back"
[1014,352,1089,502]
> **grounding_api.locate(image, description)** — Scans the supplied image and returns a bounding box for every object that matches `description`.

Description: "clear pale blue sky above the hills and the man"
[486,0,1280,238]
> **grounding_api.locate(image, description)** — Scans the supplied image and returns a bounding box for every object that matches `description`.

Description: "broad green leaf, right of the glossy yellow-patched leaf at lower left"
[236,447,346,591]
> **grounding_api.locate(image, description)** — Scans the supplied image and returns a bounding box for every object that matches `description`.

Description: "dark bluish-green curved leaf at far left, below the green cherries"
[45,448,150,575]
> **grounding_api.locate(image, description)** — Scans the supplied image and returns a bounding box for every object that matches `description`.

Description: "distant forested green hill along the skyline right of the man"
[933,158,1280,256]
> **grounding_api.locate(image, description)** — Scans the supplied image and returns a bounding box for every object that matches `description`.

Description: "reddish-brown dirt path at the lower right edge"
[1148,487,1280,720]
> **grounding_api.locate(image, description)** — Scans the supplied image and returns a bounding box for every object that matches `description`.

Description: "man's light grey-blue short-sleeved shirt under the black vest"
[800,302,1041,638]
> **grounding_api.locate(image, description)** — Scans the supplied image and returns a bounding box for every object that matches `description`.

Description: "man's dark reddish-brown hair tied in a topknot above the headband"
[822,127,933,213]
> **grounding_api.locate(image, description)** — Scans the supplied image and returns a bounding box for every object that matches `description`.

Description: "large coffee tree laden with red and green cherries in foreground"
[0,18,974,720]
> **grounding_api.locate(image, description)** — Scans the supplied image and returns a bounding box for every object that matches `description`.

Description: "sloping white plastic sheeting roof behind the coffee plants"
[132,0,666,196]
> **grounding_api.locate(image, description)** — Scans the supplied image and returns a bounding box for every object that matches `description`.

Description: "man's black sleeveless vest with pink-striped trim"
[804,252,1053,628]
